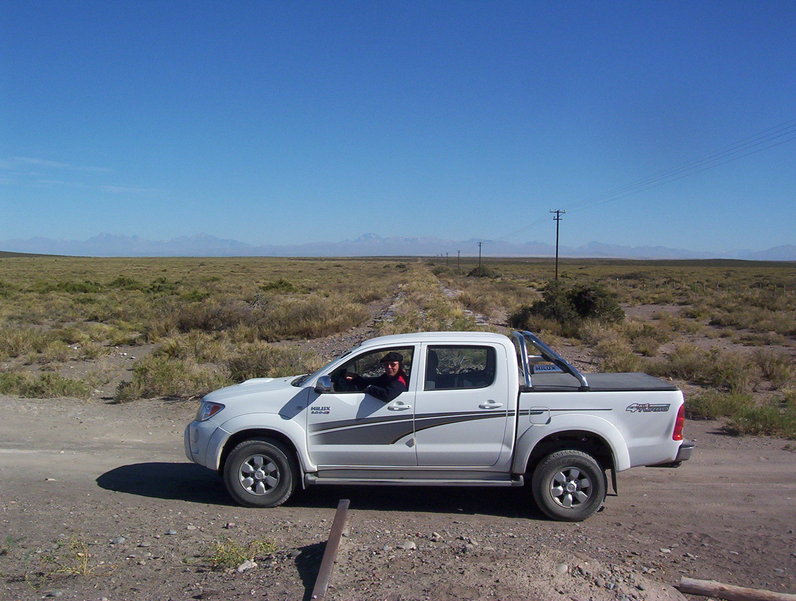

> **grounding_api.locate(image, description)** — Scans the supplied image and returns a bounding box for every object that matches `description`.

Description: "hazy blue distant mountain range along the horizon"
[0,234,796,261]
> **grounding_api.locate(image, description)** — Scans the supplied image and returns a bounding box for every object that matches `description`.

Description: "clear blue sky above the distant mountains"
[0,0,796,251]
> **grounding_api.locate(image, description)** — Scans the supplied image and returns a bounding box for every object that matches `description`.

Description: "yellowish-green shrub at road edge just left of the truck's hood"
[115,355,230,401]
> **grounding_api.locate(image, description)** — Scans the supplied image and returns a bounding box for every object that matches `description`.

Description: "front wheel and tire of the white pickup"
[224,438,299,507]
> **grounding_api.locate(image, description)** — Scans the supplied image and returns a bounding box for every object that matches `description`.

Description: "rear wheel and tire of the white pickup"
[531,449,607,522]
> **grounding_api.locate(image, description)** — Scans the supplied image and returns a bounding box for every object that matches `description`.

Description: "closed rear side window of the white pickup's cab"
[423,345,496,390]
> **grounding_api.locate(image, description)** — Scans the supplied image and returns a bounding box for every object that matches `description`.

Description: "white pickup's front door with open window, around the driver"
[307,347,417,469]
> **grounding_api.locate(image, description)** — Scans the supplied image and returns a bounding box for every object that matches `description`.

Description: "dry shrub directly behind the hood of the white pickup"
[227,342,322,382]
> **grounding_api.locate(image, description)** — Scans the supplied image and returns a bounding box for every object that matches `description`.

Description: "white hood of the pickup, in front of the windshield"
[202,376,304,417]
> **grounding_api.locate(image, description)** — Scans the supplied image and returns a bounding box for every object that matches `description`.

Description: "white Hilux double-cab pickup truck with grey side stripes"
[185,331,694,521]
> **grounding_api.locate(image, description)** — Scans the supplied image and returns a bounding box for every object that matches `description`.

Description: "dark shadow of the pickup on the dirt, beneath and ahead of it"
[96,462,547,520]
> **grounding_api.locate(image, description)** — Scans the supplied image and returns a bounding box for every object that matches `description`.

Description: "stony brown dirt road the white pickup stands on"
[0,397,796,601]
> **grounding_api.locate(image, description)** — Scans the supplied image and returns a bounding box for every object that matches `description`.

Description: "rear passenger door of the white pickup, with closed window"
[415,343,511,469]
